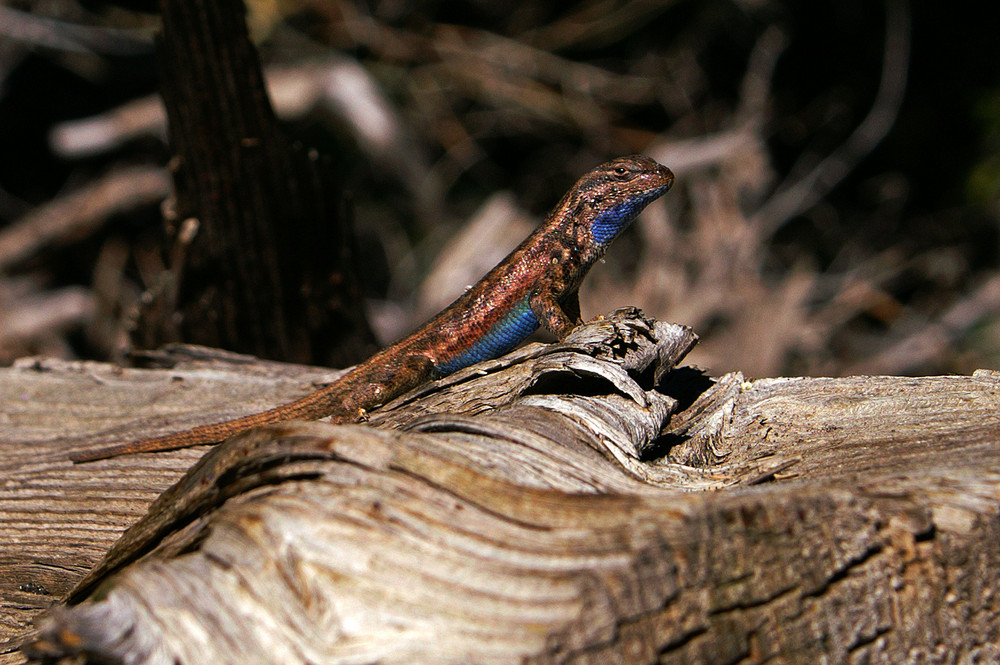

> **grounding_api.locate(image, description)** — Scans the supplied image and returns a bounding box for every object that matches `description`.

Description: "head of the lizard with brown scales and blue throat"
[570,155,674,247]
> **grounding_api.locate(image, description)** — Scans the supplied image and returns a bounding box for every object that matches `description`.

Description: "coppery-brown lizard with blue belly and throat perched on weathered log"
[70,155,674,463]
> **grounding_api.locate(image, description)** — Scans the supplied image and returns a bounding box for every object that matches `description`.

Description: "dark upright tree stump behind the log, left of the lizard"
[134,0,374,367]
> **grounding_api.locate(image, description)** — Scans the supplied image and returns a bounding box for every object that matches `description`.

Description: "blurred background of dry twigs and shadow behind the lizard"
[0,0,1000,377]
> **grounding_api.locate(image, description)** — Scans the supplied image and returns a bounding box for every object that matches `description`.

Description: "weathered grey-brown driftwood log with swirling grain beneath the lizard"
[0,310,1000,665]
